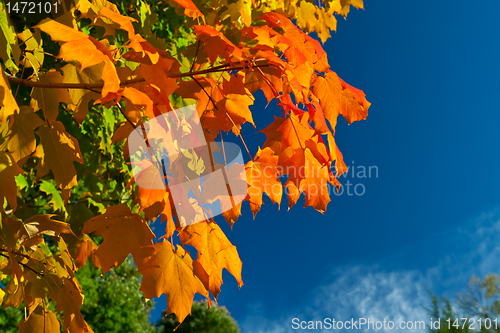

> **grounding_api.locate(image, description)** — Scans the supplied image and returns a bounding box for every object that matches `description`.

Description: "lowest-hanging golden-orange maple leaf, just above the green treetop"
[134,240,208,322]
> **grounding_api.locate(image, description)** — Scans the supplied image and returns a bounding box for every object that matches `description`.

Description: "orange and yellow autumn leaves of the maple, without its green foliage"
[0,0,370,332]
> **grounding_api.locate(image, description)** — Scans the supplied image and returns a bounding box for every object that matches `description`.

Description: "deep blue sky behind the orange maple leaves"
[154,0,500,333]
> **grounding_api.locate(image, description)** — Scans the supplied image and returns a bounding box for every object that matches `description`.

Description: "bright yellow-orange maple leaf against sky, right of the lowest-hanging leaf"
[179,221,243,299]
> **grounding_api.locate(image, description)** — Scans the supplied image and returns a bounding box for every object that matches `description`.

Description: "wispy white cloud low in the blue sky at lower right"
[241,206,500,333]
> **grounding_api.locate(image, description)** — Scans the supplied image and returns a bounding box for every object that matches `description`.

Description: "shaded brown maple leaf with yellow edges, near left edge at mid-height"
[35,121,83,201]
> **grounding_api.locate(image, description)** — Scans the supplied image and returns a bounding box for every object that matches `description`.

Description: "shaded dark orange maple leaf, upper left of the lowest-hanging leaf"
[82,204,155,273]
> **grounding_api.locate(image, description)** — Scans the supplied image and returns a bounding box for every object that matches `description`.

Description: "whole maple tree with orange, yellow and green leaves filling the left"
[0,0,370,332]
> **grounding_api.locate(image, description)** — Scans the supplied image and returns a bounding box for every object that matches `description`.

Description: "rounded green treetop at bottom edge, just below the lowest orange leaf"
[157,302,240,333]
